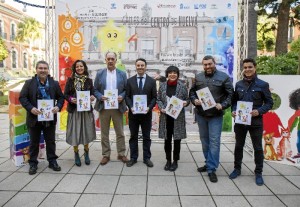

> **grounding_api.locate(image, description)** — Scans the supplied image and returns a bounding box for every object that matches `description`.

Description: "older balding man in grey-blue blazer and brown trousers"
[94,52,128,165]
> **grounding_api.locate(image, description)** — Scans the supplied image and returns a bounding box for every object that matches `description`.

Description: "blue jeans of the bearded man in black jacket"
[196,114,223,173]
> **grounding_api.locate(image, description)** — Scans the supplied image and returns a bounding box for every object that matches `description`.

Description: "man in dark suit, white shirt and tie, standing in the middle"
[126,58,157,167]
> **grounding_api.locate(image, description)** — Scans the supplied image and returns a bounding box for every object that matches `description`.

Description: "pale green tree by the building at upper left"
[16,17,42,49]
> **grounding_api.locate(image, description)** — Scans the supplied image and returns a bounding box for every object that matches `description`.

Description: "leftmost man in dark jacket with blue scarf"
[19,61,64,175]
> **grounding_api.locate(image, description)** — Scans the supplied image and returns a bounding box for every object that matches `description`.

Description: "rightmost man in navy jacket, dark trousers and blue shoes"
[229,58,273,186]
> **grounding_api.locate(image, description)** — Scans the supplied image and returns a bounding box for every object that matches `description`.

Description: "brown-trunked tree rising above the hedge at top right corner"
[259,0,300,55]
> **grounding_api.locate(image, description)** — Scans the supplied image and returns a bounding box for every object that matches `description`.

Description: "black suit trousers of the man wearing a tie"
[129,113,152,160]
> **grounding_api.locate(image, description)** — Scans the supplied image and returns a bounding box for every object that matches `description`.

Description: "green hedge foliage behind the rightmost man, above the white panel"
[256,52,298,75]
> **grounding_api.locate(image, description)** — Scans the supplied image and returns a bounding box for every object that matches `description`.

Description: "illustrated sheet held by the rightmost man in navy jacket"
[235,101,253,125]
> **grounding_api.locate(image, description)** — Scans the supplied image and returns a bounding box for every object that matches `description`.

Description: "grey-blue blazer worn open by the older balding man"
[94,68,127,113]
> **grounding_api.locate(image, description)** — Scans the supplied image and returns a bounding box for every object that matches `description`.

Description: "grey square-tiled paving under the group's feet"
[0,114,300,207]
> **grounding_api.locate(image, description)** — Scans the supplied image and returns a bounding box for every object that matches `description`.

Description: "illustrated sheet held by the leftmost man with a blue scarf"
[37,99,54,121]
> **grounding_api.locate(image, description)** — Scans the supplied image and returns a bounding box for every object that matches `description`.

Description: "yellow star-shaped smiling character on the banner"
[98,19,126,52]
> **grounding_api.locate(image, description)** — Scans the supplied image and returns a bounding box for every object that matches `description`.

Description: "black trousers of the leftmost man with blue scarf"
[28,123,58,165]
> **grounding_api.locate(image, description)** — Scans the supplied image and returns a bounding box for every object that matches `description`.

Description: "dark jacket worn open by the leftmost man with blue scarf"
[19,75,64,127]
